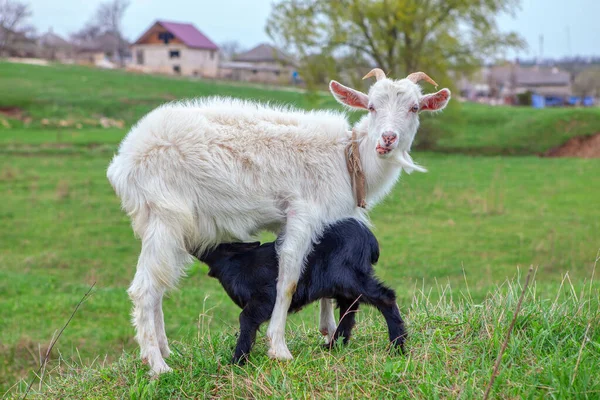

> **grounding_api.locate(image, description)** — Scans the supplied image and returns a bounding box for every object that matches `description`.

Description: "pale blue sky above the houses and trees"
[25,0,600,57]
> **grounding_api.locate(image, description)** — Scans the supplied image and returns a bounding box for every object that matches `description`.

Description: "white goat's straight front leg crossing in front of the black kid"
[267,204,319,360]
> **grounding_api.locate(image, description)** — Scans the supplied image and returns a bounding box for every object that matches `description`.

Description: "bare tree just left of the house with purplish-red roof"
[71,0,130,65]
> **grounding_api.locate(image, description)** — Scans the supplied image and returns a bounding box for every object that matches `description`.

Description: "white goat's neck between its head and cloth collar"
[354,118,402,209]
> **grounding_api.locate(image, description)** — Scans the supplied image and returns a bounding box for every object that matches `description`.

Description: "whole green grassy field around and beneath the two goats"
[0,63,600,398]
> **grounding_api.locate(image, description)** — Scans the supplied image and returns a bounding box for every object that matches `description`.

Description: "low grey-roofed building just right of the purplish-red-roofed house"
[219,43,295,84]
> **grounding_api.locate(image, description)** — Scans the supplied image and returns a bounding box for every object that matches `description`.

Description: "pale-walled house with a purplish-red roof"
[131,20,219,78]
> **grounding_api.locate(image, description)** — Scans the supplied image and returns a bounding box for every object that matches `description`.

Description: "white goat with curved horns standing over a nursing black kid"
[107,69,450,373]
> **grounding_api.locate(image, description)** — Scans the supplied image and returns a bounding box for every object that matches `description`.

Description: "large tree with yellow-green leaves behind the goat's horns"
[266,0,524,87]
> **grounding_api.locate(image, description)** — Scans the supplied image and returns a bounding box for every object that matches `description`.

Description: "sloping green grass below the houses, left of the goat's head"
[0,62,336,129]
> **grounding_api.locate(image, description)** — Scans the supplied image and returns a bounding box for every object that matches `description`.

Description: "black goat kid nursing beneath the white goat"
[196,219,406,363]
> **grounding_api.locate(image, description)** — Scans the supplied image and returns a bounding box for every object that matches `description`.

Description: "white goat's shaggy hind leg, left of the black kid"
[127,219,190,374]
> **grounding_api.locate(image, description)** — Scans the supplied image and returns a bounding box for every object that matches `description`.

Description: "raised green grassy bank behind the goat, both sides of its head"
[0,62,600,155]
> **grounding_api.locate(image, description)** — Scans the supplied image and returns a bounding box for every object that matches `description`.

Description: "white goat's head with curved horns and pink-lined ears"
[329,68,450,157]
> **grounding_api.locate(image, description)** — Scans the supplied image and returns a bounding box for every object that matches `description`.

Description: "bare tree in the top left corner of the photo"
[0,0,35,56]
